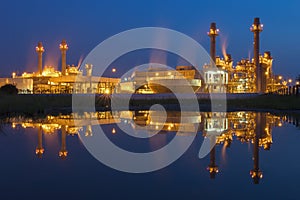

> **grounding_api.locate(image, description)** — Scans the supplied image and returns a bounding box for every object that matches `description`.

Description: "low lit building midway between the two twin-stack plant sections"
[117,66,202,94]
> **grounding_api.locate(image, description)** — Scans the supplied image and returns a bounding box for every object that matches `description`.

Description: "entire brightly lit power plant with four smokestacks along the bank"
[0,18,288,94]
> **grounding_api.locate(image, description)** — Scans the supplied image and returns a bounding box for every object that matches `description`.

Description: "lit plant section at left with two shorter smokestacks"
[7,40,120,94]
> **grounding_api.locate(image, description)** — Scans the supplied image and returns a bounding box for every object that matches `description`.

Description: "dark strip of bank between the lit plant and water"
[0,94,300,116]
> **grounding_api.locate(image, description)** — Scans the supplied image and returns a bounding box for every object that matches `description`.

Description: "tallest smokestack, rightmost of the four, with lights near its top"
[250,18,264,93]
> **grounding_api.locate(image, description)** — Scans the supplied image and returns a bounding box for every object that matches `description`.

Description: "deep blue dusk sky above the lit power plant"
[0,0,300,78]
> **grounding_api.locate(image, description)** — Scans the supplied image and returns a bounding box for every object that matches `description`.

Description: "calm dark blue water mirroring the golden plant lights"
[0,111,300,199]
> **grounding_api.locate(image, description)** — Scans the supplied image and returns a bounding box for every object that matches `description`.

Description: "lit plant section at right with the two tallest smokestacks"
[203,18,286,93]
